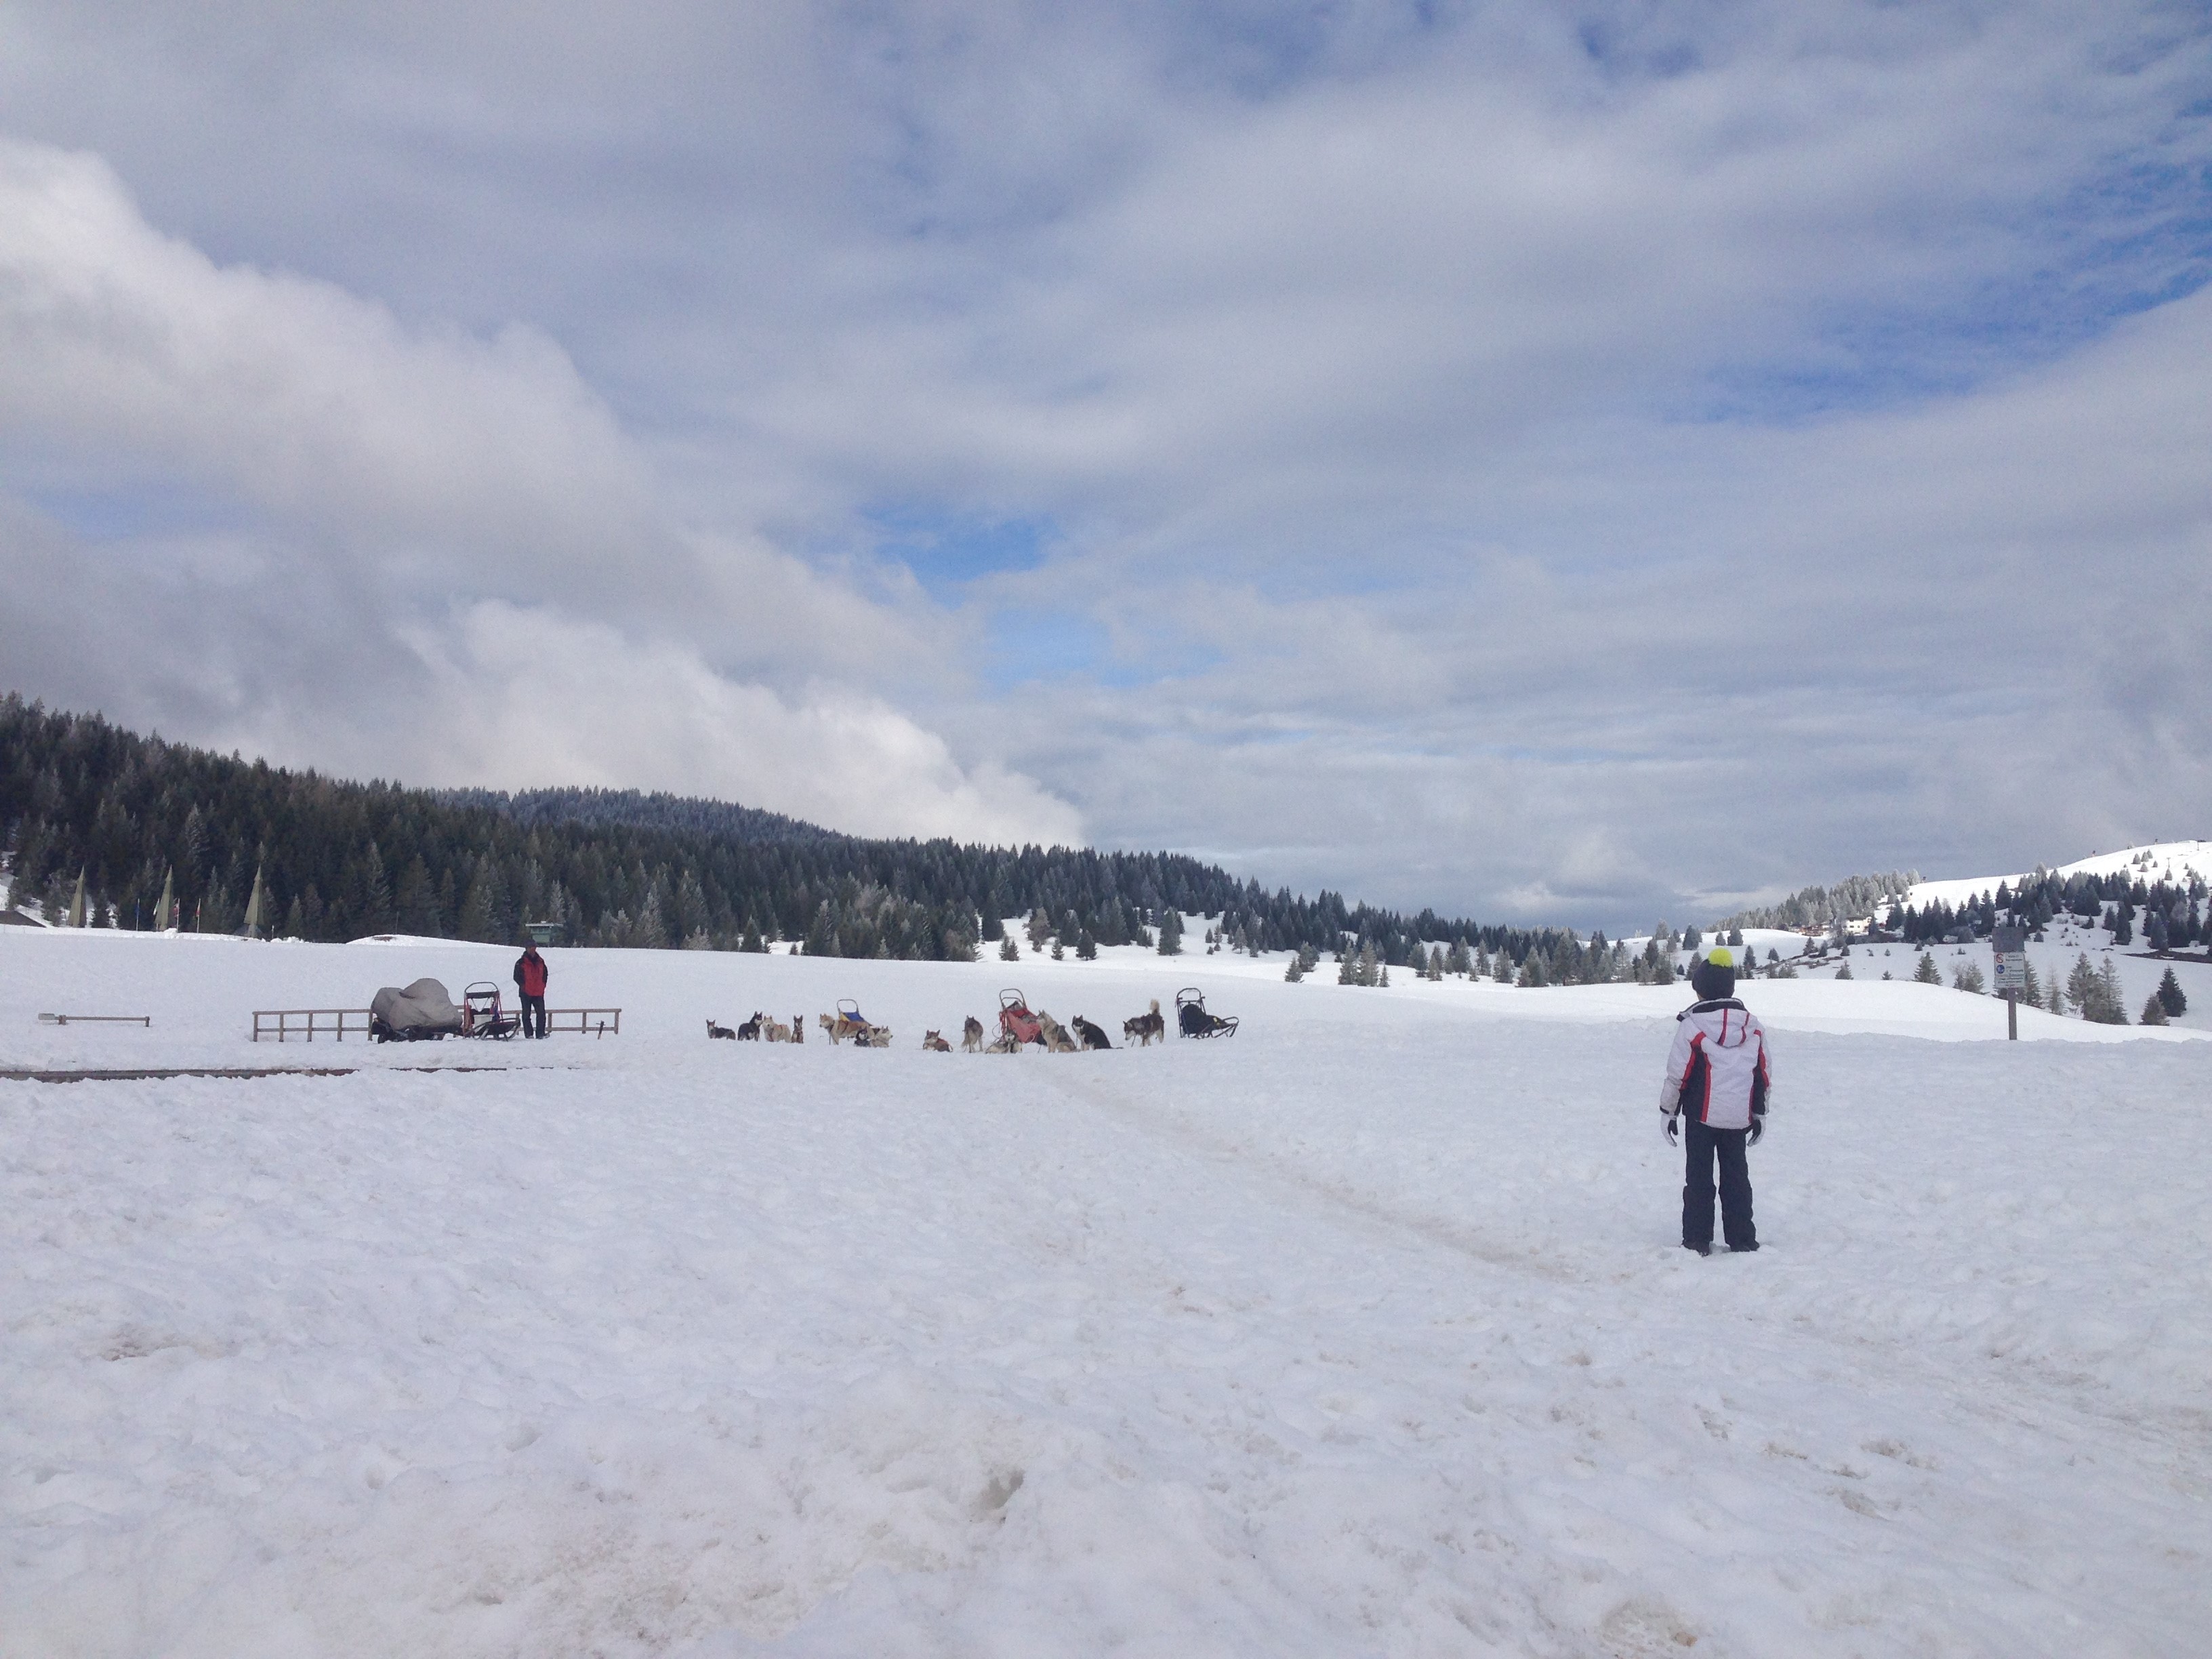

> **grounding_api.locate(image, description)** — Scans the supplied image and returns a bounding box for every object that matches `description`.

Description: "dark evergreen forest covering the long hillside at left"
[0,693,1584,971]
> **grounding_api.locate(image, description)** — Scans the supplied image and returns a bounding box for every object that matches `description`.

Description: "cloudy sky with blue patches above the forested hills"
[0,0,2212,929]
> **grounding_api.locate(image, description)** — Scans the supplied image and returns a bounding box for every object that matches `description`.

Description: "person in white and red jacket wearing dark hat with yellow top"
[1659,947,1771,1256]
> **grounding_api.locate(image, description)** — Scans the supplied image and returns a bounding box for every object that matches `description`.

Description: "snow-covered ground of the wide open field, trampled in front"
[0,929,2212,1657]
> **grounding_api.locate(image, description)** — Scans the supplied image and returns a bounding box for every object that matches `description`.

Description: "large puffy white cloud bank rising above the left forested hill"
[0,133,1082,840]
